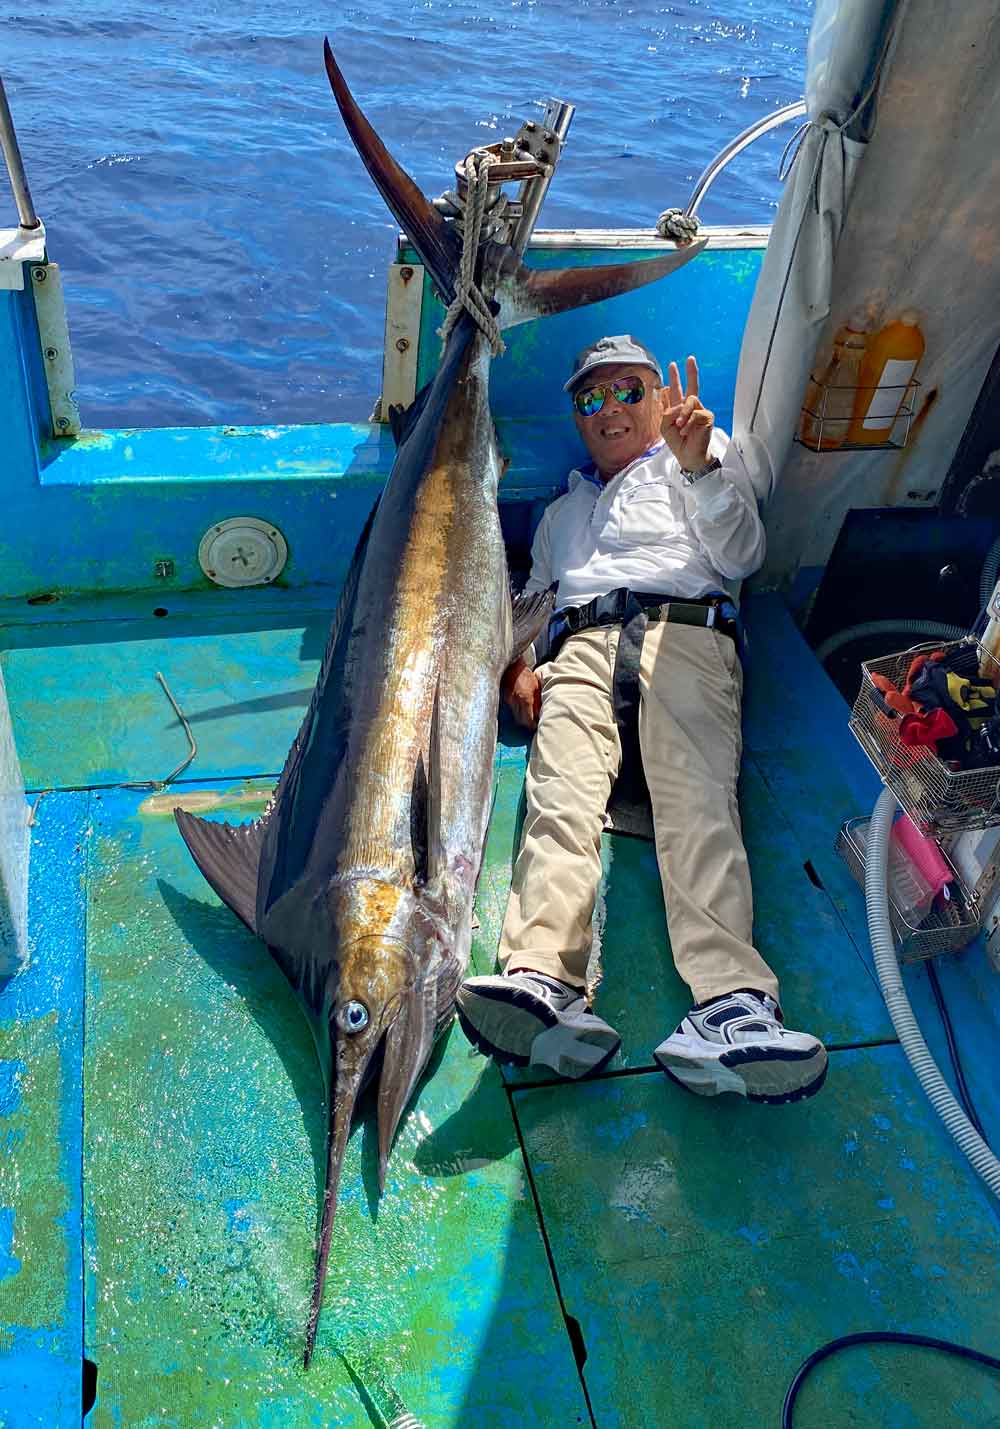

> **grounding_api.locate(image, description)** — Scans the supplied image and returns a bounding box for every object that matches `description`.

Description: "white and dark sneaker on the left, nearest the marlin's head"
[456,973,621,1079]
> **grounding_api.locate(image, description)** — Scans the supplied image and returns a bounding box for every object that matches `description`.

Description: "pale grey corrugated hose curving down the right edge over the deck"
[864,789,1000,1198]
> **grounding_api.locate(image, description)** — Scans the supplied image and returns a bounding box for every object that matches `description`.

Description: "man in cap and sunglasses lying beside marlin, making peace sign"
[459,336,827,1102]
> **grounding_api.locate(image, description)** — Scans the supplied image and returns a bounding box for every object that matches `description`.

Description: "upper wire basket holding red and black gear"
[850,640,1000,832]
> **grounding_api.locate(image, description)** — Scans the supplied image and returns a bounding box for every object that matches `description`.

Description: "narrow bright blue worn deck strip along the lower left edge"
[0,795,89,1429]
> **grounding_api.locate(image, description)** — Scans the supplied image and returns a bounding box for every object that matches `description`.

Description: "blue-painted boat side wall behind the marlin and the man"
[0,229,767,608]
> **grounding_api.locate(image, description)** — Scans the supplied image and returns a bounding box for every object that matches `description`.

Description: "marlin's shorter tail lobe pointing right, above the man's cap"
[496,239,709,327]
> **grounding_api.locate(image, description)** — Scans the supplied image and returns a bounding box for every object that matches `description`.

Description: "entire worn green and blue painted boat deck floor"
[0,596,1000,1429]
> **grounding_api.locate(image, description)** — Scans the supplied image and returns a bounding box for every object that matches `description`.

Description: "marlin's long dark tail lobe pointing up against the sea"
[323,40,461,303]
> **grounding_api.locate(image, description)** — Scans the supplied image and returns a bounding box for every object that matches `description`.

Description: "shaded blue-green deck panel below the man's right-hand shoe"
[514,1046,1000,1429]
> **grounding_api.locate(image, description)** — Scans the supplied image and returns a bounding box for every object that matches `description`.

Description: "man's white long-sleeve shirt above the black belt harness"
[526,430,764,606]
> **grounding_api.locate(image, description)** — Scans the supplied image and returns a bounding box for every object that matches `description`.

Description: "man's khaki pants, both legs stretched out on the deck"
[500,622,777,1002]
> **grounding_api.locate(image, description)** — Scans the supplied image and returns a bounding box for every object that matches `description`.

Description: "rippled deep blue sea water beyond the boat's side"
[0,0,811,426]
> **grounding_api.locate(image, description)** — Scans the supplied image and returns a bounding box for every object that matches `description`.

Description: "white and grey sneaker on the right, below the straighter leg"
[653,990,827,1103]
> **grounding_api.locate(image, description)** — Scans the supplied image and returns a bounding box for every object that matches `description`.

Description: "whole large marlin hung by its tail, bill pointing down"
[176,44,703,1365]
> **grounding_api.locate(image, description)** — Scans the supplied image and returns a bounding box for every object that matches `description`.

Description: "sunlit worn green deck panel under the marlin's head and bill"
[84,782,586,1426]
